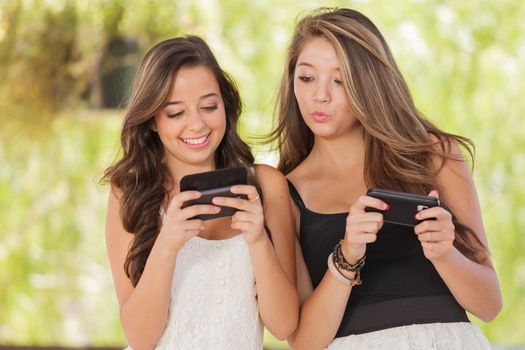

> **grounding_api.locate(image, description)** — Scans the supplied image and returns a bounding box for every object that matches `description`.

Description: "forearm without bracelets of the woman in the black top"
[433,248,502,322]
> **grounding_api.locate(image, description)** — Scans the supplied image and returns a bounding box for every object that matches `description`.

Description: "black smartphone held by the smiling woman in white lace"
[180,167,248,220]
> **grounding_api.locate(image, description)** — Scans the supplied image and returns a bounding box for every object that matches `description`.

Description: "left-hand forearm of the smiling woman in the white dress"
[120,242,176,350]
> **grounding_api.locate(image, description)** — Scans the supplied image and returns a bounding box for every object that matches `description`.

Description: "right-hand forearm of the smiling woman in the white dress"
[250,236,299,340]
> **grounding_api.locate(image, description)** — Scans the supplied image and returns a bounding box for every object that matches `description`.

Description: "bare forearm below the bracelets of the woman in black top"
[290,270,354,350]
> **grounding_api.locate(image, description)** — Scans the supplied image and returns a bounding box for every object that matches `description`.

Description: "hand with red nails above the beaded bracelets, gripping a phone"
[341,195,389,264]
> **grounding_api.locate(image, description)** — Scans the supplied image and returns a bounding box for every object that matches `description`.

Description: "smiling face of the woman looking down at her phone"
[154,66,226,171]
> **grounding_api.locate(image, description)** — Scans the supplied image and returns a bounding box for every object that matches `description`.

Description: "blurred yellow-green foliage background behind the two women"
[0,0,525,346]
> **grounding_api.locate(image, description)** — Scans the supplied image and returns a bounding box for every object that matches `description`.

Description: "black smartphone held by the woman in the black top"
[365,188,440,227]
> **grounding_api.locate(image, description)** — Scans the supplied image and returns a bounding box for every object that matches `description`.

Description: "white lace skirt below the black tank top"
[327,322,491,350]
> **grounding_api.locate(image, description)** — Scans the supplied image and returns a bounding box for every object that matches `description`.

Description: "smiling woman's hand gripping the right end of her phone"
[213,185,266,244]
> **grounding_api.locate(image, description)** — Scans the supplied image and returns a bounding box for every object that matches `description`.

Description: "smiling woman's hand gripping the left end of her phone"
[157,191,221,252]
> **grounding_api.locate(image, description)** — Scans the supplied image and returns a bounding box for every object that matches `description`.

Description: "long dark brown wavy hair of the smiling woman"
[102,36,258,286]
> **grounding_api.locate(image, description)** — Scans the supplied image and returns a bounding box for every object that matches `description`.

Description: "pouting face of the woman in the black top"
[294,37,357,138]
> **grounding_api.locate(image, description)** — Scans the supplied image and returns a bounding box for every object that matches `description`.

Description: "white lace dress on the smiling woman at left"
[129,235,263,350]
